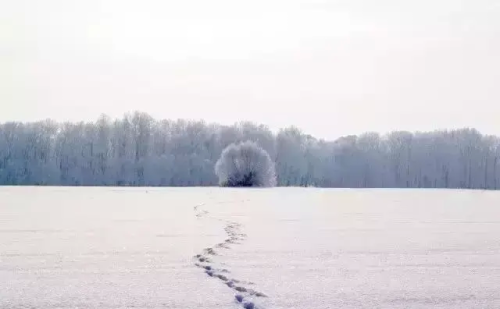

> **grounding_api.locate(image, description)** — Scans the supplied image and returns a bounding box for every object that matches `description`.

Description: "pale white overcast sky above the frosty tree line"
[0,0,500,138]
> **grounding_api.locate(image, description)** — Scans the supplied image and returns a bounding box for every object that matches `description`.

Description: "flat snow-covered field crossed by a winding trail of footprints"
[0,188,500,309]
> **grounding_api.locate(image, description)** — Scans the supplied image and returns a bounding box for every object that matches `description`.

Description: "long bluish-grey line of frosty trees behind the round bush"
[0,112,500,189]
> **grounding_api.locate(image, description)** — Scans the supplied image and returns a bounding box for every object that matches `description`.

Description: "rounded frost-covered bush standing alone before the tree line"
[215,141,276,187]
